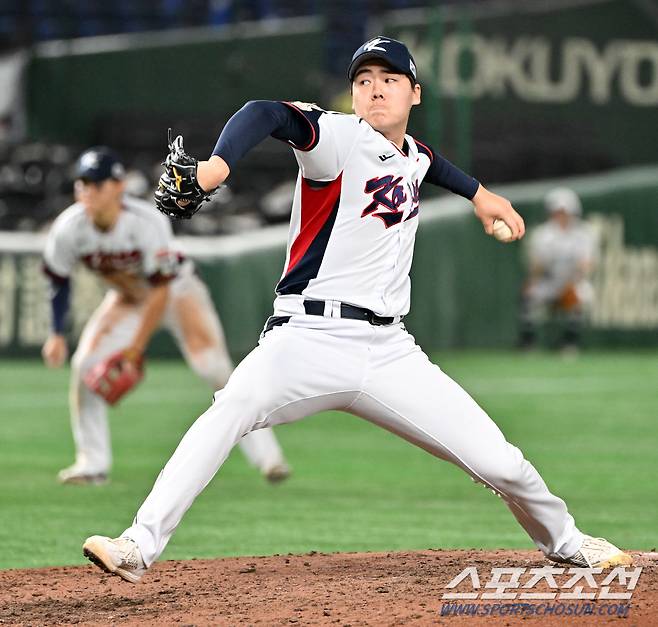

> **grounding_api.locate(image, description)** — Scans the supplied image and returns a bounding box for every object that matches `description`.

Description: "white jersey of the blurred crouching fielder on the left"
[44,196,183,286]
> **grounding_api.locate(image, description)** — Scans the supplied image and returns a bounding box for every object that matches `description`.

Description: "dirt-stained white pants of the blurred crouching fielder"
[69,272,284,474]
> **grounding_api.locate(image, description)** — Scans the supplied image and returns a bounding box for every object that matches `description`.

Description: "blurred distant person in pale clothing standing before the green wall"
[520,187,597,351]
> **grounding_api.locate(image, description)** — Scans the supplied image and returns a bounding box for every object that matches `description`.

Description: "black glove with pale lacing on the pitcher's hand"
[155,129,216,220]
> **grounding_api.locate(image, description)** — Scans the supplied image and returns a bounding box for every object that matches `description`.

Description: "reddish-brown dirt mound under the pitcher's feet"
[0,550,658,627]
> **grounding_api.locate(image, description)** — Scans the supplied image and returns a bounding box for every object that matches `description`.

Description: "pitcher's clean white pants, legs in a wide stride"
[123,315,582,566]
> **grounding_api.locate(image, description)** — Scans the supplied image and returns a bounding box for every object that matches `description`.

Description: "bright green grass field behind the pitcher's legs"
[0,352,658,568]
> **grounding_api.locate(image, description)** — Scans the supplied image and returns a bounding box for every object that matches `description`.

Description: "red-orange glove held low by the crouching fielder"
[84,351,144,405]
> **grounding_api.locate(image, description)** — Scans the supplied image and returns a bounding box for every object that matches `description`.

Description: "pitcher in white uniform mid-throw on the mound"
[83,37,631,583]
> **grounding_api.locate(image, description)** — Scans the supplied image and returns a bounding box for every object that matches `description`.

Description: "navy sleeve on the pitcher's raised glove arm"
[212,100,313,168]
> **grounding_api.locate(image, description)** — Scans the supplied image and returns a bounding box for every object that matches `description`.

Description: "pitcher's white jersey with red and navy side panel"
[275,103,433,316]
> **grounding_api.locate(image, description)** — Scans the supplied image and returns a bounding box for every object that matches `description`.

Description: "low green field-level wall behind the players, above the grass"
[0,166,658,358]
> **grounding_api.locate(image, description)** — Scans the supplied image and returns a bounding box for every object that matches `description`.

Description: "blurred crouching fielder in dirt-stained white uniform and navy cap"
[42,147,288,484]
